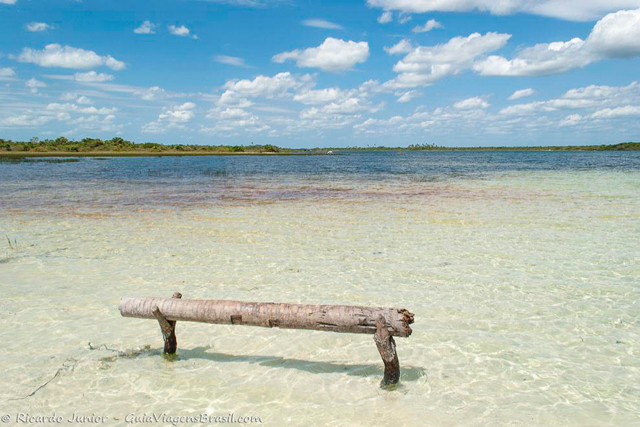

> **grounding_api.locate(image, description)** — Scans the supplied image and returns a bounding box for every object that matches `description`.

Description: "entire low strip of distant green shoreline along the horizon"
[0,137,640,157]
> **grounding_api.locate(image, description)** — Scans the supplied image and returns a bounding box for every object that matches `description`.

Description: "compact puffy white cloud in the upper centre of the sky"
[273,37,369,72]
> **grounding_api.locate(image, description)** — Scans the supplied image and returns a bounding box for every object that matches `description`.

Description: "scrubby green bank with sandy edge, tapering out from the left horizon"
[0,136,287,153]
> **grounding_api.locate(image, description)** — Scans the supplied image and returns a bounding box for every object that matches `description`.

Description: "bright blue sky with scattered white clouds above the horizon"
[0,0,640,147]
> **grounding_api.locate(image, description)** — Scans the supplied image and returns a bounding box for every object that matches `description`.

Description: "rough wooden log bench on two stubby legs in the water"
[118,292,413,385]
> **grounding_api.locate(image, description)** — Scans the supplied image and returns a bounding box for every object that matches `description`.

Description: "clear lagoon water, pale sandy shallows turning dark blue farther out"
[0,152,640,426]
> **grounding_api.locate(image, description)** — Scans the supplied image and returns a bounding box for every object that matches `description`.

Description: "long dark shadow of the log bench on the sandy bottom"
[178,347,427,381]
